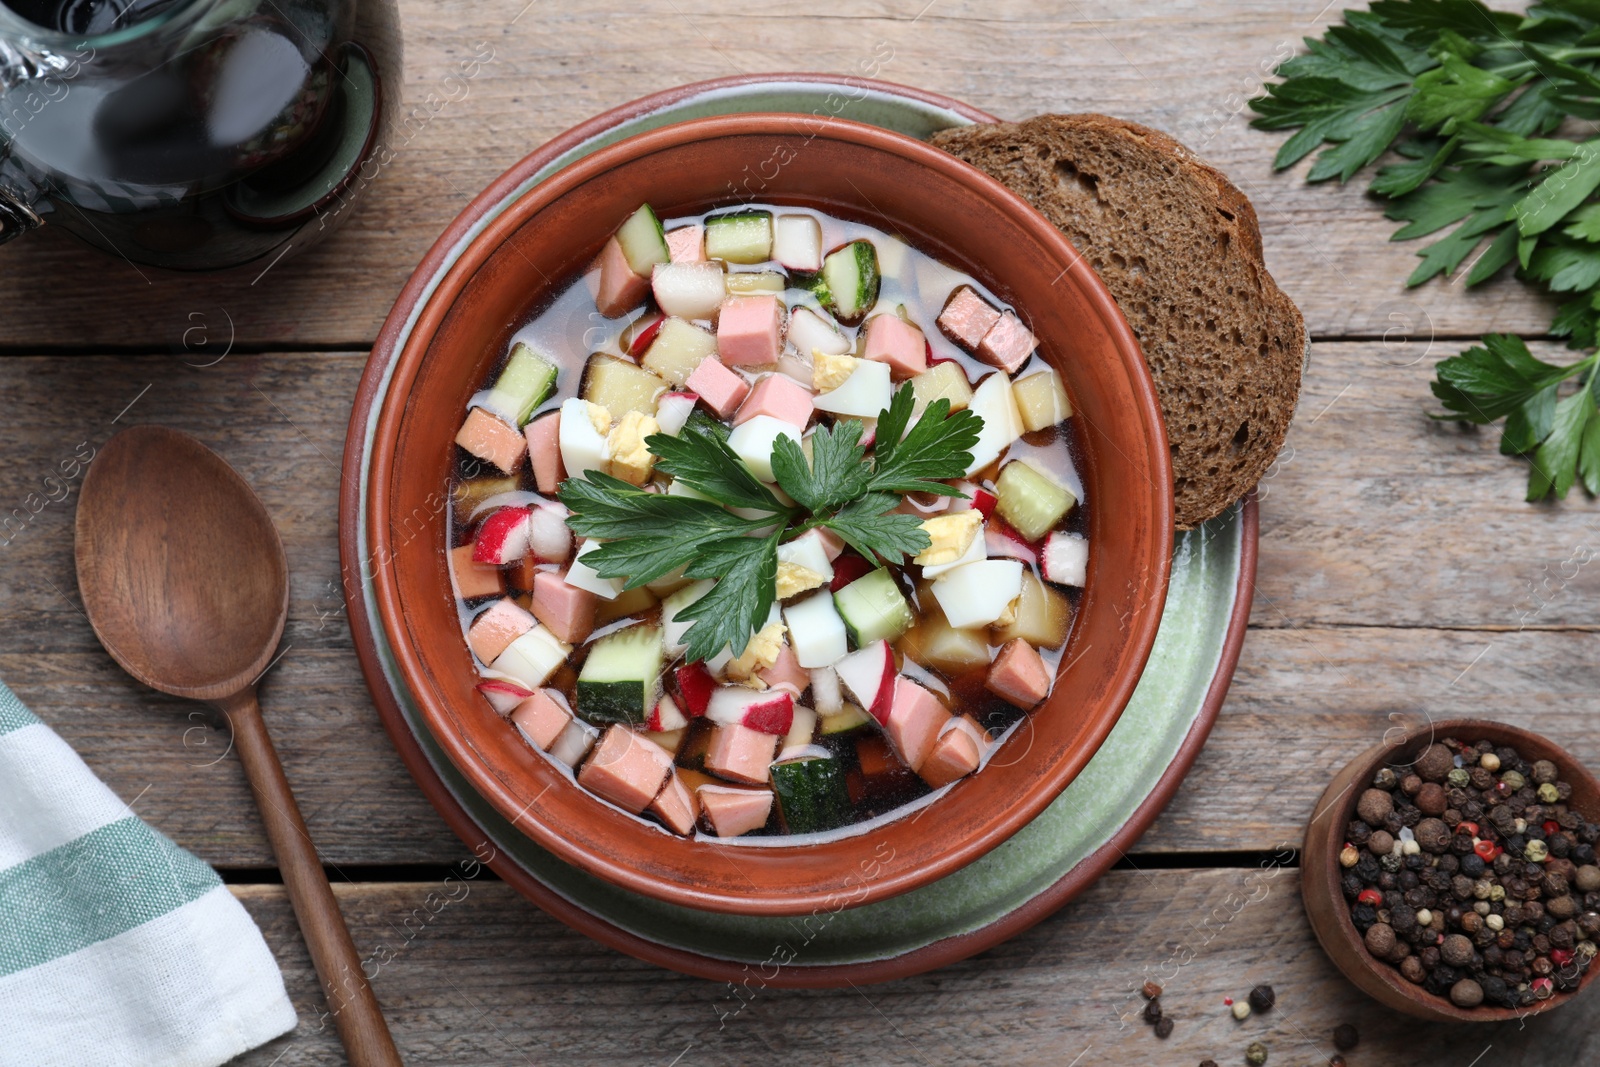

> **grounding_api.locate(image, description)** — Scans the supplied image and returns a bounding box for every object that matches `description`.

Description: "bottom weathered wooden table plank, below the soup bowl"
[235,869,1600,1067]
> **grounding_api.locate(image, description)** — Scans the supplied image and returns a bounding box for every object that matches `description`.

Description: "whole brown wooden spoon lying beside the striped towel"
[77,426,402,1067]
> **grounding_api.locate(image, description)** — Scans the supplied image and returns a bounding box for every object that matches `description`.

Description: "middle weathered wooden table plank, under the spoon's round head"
[0,351,1600,867]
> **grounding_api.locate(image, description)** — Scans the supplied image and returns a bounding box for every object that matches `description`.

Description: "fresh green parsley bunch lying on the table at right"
[1251,0,1600,501]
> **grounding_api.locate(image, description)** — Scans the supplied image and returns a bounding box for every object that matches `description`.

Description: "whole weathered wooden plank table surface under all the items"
[0,0,1600,1067]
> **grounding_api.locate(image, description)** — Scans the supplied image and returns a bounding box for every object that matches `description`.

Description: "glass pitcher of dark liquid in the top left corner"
[0,0,402,270]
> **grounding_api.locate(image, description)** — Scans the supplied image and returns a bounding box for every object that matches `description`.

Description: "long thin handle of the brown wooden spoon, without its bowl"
[222,688,402,1067]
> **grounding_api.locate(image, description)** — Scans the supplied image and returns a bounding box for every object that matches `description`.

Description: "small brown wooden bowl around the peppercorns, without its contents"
[1301,718,1600,1022]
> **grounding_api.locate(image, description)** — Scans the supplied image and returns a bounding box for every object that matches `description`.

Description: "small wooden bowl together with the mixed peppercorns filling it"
[1301,720,1600,1022]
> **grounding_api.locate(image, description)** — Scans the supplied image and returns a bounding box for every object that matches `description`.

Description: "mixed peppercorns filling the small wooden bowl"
[1344,737,1600,1017]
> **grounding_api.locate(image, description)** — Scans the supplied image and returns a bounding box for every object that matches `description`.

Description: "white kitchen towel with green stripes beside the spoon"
[0,681,294,1067]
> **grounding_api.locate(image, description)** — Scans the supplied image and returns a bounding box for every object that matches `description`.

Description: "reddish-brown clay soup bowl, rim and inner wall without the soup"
[363,114,1173,915]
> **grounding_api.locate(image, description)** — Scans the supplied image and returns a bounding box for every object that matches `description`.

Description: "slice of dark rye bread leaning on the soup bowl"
[933,115,1309,530]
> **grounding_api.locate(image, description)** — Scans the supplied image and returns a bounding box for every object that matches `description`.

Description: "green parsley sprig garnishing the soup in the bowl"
[560,386,982,661]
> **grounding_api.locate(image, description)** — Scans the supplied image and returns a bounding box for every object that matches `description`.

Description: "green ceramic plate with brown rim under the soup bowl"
[341,75,1256,985]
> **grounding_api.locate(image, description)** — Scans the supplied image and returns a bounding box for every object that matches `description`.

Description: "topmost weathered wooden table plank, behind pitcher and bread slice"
[0,0,1550,350]
